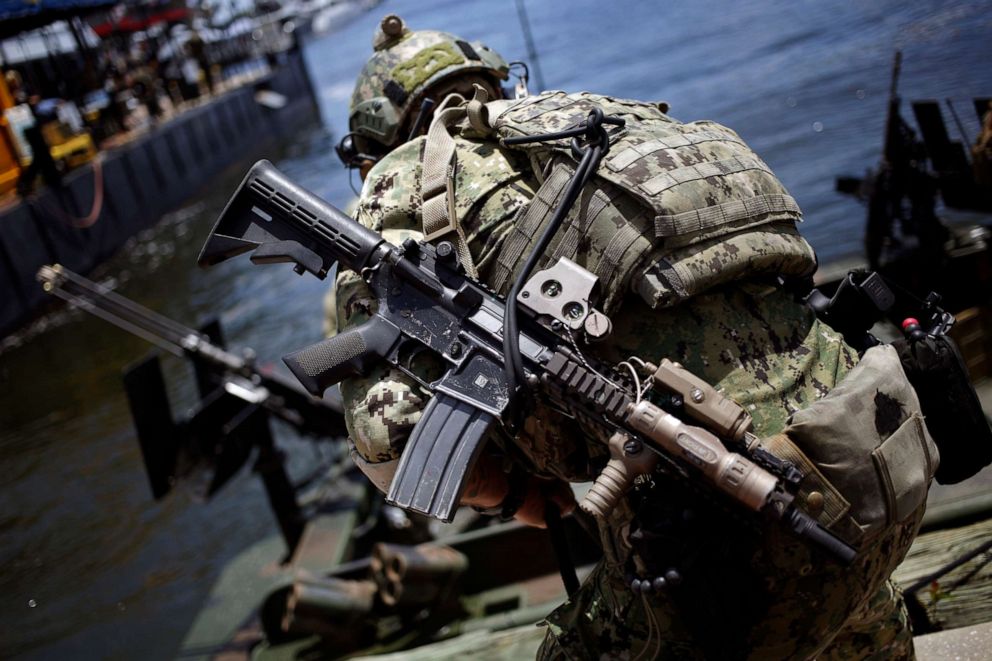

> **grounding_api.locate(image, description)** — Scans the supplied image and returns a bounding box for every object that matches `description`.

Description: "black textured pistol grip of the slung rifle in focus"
[283,315,400,397]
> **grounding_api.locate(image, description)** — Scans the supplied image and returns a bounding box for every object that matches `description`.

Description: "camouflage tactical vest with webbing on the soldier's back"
[422,92,816,314]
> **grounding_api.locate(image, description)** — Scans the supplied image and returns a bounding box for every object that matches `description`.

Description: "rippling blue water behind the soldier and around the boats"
[0,0,992,659]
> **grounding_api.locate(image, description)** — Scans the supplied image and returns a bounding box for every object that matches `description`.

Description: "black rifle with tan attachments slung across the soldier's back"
[199,161,856,563]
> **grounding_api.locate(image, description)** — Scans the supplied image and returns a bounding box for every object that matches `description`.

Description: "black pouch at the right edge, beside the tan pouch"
[892,335,992,484]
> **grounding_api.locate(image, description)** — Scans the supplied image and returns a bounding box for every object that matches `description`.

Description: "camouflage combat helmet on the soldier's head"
[337,14,509,166]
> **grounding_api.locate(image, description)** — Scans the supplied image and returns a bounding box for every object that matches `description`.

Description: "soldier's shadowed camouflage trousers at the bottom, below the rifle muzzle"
[538,508,923,661]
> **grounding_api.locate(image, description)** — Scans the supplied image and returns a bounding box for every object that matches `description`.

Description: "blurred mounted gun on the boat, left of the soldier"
[37,264,347,550]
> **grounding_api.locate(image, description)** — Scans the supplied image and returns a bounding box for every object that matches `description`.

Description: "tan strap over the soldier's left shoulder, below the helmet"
[420,100,479,278]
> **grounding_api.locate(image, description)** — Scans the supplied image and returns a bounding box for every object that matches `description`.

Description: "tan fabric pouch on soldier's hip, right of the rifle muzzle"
[761,345,939,544]
